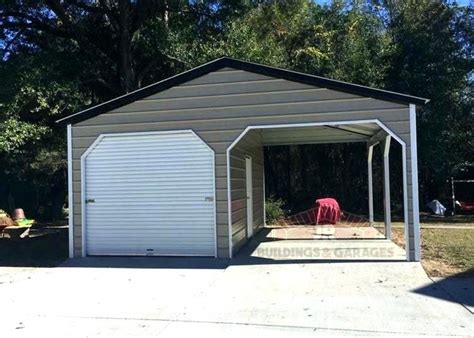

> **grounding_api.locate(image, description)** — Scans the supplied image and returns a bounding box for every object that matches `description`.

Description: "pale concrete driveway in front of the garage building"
[0,257,474,337]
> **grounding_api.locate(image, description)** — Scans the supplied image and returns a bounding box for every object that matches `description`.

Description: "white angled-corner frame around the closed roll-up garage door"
[81,129,217,257]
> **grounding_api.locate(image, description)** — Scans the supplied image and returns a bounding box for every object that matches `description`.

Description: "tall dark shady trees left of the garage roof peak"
[0,0,256,218]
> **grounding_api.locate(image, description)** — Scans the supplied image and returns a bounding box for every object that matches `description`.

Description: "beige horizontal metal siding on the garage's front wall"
[72,69,411,257]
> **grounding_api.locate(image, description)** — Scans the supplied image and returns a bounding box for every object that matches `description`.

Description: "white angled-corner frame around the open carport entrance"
[227,117,412,261]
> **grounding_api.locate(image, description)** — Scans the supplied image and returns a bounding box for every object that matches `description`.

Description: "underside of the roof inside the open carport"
[262,123,382,146]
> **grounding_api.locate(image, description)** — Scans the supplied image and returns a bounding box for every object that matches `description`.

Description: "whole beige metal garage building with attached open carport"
[58,58,427,260]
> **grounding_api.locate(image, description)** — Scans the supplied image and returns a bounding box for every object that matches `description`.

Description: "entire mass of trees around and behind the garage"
[0,0,474,217]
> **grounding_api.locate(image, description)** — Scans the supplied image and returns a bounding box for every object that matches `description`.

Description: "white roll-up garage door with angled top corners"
[81,131,216,256]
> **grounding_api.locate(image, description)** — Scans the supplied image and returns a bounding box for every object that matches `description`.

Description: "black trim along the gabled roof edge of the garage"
[56,57,429,125]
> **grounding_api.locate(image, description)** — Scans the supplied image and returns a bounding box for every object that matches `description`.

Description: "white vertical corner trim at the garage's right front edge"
[410,104,421,261]
